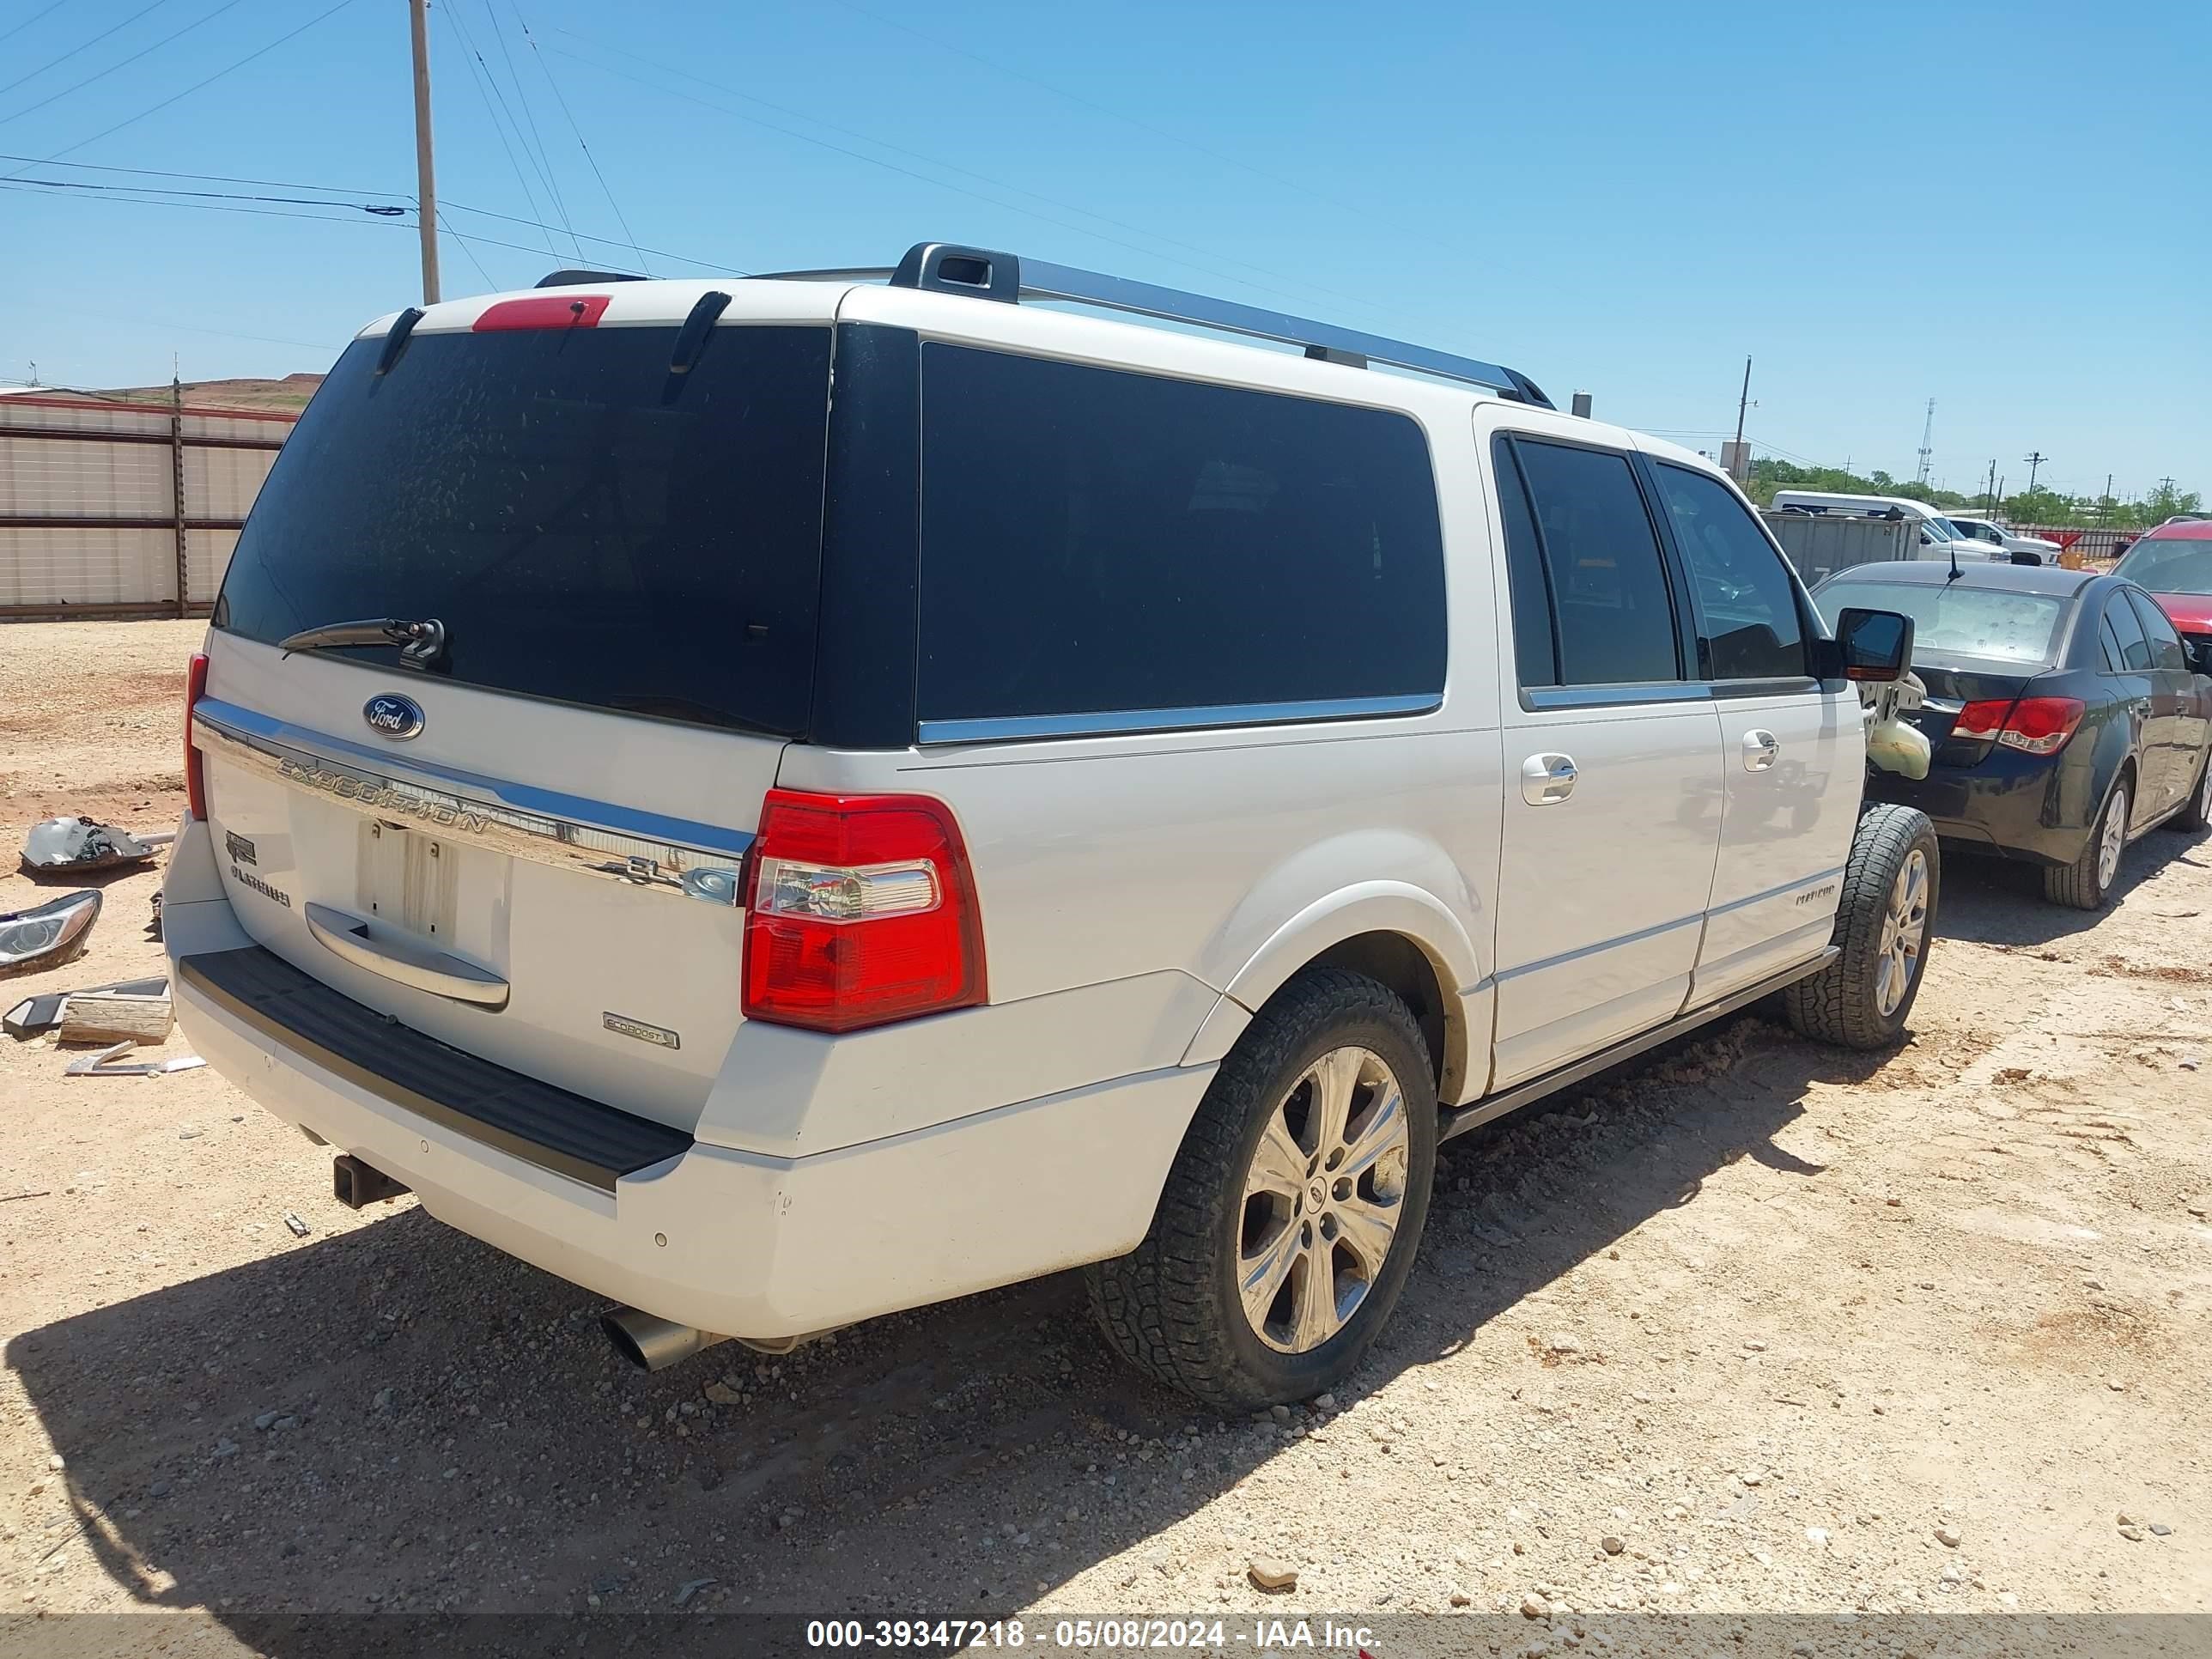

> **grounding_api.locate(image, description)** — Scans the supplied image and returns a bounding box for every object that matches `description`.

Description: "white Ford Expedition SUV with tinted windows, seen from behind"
[164,243,1938,1407]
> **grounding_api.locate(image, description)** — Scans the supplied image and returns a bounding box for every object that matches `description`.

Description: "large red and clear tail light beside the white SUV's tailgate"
[745,790,984,1030]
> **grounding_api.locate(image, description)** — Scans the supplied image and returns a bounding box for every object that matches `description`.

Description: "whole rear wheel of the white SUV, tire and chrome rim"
[1086,969,1436,1411]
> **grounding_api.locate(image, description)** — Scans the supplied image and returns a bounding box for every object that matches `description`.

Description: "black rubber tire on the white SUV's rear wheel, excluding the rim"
[1084,969,1436,1411]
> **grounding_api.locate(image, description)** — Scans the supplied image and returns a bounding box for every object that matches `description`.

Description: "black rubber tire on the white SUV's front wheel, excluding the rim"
[1783,805,1942,1048]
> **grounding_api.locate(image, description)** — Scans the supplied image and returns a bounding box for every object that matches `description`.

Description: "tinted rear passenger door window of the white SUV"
[1513,438,1683,686]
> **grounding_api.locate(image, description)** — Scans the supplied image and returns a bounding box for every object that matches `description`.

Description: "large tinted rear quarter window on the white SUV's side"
[918,345,1444,721]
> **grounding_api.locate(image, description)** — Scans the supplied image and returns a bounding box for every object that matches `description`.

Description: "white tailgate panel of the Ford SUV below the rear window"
[195,635,783,1128]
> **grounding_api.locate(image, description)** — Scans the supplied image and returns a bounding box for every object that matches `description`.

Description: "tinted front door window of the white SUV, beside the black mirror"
[1655,467,1805,679]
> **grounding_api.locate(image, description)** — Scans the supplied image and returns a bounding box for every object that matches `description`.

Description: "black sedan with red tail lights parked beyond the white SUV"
[1814,560,2212,909]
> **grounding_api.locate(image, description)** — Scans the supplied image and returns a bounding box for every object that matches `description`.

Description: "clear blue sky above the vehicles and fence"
[0,0,2212,493]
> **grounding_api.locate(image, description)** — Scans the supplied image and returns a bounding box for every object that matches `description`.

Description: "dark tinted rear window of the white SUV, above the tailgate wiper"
[215,325,830,737]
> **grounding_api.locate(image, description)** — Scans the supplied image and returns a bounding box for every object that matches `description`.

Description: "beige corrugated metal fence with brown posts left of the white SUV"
[0,396,296,622]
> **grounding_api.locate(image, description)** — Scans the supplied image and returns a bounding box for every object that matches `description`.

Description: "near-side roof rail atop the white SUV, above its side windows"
[772,241,1555,410]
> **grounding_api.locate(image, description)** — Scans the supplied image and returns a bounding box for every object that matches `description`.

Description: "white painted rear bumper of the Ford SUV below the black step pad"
[166,928,1214,1338]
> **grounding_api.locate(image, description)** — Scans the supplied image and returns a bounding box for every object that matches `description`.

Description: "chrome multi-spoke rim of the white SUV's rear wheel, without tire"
[1237,1048,1411,1354]
